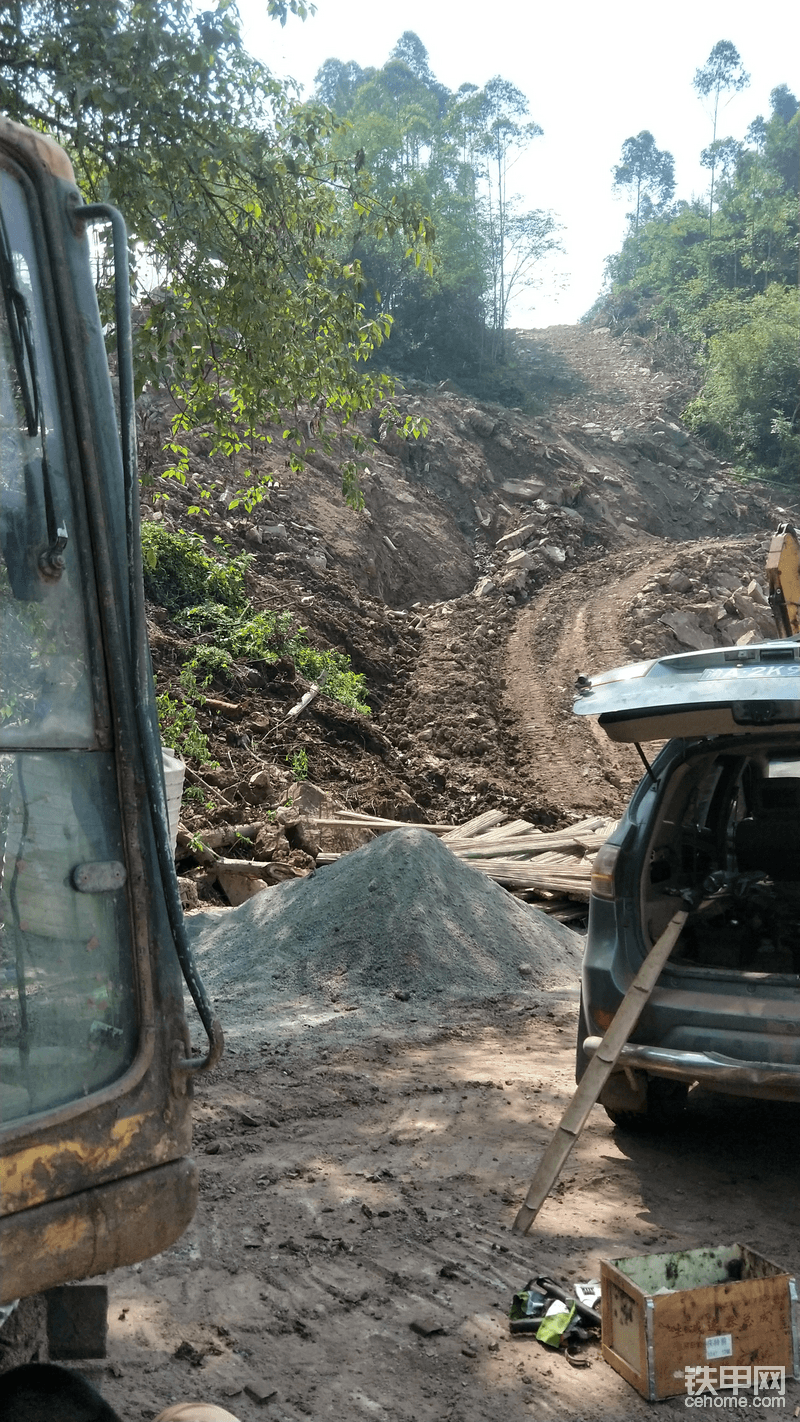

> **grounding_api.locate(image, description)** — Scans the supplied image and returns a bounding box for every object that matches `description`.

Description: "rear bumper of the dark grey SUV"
[583,1037,800,1101]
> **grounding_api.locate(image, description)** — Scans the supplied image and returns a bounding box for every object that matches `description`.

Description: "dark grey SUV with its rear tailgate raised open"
[574,638,800,1125]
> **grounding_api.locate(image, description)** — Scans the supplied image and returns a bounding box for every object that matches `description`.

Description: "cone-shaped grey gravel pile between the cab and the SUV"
[186,828,583,1039]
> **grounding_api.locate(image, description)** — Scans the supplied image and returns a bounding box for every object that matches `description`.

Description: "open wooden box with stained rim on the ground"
[600,1244,800,1402]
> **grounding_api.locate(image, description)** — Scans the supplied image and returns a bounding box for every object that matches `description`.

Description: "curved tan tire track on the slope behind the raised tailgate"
[506,553,675,813]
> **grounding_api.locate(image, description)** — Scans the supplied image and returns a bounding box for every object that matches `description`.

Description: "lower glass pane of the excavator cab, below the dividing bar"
[0,752,135,1123]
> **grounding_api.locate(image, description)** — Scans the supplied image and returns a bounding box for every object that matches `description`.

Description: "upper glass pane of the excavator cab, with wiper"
[0,169,94,747]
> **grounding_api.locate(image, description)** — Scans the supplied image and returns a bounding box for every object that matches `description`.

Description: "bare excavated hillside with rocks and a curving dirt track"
[145,327,797,887]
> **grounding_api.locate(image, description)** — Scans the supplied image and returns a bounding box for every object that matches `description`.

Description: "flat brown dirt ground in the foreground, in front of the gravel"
[94,993,800,1422]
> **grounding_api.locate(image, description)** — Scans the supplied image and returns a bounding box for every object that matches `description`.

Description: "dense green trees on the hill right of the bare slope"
[594,50,800,481]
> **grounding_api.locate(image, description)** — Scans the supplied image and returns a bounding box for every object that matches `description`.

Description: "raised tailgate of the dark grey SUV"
[573,637,800,741]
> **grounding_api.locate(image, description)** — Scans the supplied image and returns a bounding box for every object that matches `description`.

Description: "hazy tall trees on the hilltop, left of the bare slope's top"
[309,31,557,392]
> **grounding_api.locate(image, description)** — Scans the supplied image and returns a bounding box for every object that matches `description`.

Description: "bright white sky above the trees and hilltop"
[239,0,800,327]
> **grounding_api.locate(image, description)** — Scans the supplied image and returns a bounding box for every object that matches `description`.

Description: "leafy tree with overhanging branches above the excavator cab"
[0,0,429,509]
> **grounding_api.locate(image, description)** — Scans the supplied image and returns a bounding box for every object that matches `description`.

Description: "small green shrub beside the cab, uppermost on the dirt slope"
[142,522,253,611]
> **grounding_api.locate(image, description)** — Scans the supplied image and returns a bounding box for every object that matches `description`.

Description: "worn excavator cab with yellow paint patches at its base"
[0,118,222,1304]
